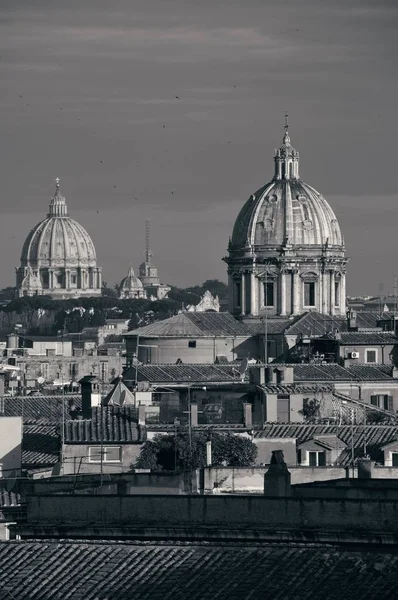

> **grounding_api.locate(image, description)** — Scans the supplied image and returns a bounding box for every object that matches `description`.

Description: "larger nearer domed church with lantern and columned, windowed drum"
[224,113,347,317]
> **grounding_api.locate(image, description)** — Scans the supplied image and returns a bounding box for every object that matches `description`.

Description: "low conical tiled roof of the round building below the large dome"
[125,312,252,338]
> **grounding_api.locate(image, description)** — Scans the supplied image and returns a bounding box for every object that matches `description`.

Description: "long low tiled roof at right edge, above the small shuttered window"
[268,363,392,383]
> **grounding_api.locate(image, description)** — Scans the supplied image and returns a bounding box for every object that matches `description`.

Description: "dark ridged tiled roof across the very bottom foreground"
[0,541,398,600]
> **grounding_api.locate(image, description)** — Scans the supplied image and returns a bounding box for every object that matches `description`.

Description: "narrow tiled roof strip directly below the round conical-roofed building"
[123,364,239,383]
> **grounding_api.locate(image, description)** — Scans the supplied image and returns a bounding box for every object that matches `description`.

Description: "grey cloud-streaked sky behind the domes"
[0,0,398,295]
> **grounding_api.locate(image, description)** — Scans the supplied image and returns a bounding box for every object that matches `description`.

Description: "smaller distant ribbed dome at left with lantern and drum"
[16,179,102,298]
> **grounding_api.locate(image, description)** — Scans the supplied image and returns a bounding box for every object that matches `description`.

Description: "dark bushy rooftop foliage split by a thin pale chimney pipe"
[135,432,257,471]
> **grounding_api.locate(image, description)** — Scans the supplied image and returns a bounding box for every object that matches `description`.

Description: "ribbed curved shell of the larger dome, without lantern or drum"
[232,179,344,248]
